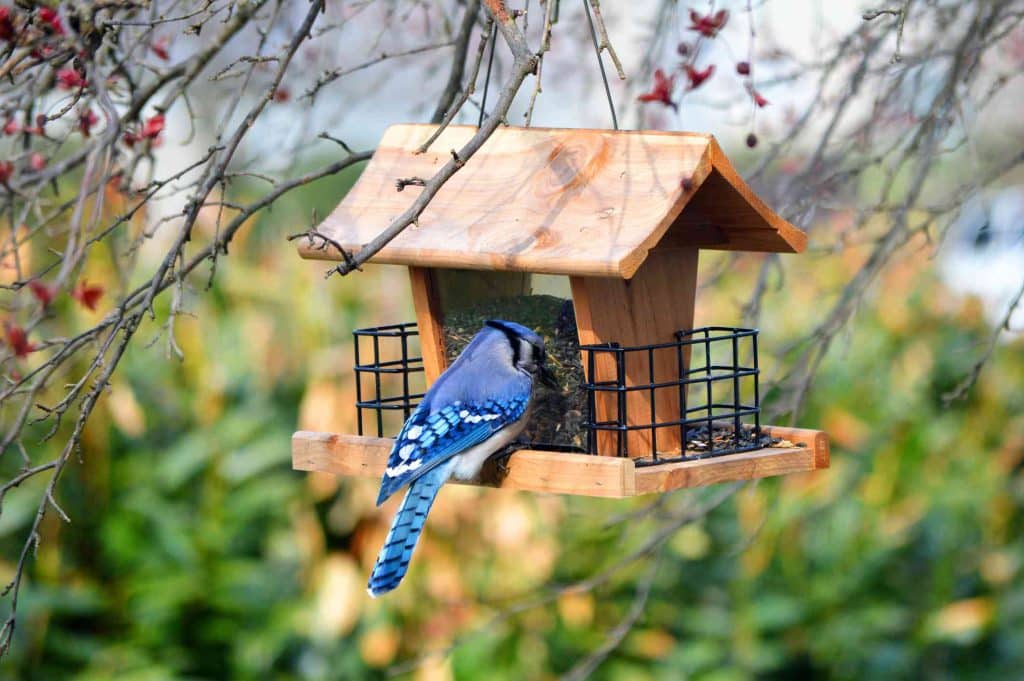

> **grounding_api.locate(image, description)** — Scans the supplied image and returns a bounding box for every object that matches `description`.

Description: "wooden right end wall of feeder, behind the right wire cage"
[569,248,697,458]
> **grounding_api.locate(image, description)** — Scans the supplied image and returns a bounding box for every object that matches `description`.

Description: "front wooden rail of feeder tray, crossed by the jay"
[292,430,636,499]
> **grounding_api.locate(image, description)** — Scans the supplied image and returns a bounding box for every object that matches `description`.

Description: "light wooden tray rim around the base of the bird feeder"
[292,426,828,499]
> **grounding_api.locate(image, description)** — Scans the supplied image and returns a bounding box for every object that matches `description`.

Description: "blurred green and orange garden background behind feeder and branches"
[0,0,1024,681]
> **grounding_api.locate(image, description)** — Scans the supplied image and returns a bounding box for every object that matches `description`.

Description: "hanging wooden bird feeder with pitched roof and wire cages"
[293,125,828,497]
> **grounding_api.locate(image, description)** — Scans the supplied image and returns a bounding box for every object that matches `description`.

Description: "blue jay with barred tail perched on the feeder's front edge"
[367,320,556,597]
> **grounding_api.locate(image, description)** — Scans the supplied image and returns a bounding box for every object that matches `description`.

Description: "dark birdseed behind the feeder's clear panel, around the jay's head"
[443,295,587,450]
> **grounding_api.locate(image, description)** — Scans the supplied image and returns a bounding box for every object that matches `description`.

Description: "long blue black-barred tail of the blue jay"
[367,461,455,597]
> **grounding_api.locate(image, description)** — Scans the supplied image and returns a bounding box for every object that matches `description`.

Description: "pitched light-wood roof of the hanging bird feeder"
[299,125,807,279]
